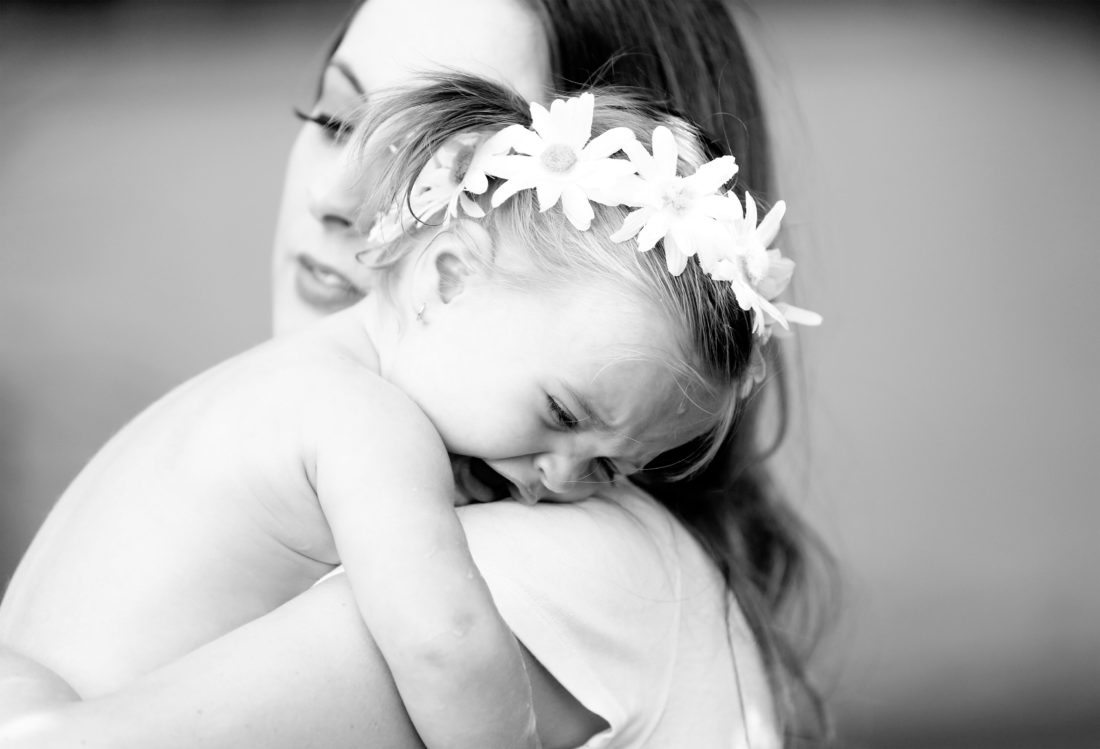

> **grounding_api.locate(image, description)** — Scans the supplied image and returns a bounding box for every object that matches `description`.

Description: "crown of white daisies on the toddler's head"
[367,93,822,387]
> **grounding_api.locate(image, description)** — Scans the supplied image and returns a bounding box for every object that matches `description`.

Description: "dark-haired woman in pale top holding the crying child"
[4,0,827,747]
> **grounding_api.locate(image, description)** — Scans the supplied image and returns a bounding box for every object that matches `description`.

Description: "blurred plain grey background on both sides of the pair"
[0,0,1100,749]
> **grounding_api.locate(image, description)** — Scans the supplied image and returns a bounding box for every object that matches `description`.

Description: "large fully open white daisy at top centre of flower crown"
[485,93,635,231]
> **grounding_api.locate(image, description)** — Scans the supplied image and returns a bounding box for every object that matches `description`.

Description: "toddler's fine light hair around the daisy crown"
[356,75,756,477]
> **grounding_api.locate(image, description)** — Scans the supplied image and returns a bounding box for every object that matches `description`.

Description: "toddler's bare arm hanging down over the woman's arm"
[314,373,538,749]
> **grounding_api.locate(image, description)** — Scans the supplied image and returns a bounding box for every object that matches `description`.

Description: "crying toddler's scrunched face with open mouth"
[387,268,713,504]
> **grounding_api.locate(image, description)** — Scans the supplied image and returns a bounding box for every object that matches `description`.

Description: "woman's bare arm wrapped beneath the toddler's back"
[0,575,605,749]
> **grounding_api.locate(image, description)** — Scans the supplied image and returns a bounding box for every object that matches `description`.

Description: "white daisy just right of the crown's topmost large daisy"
[612,125,738,276]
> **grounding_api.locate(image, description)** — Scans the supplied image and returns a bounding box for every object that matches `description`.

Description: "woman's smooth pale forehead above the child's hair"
[333,0,550,100]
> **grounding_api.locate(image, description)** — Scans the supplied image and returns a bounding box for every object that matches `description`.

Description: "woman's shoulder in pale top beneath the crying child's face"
[461,485,771,747]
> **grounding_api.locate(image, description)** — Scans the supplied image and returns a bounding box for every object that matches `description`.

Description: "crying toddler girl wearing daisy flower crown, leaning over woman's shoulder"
[0,77,817,747]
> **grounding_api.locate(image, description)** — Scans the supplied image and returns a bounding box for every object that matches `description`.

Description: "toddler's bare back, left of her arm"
[0,307,381,696]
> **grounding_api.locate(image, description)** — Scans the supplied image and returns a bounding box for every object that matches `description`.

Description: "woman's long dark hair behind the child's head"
[319,0,829,745]
